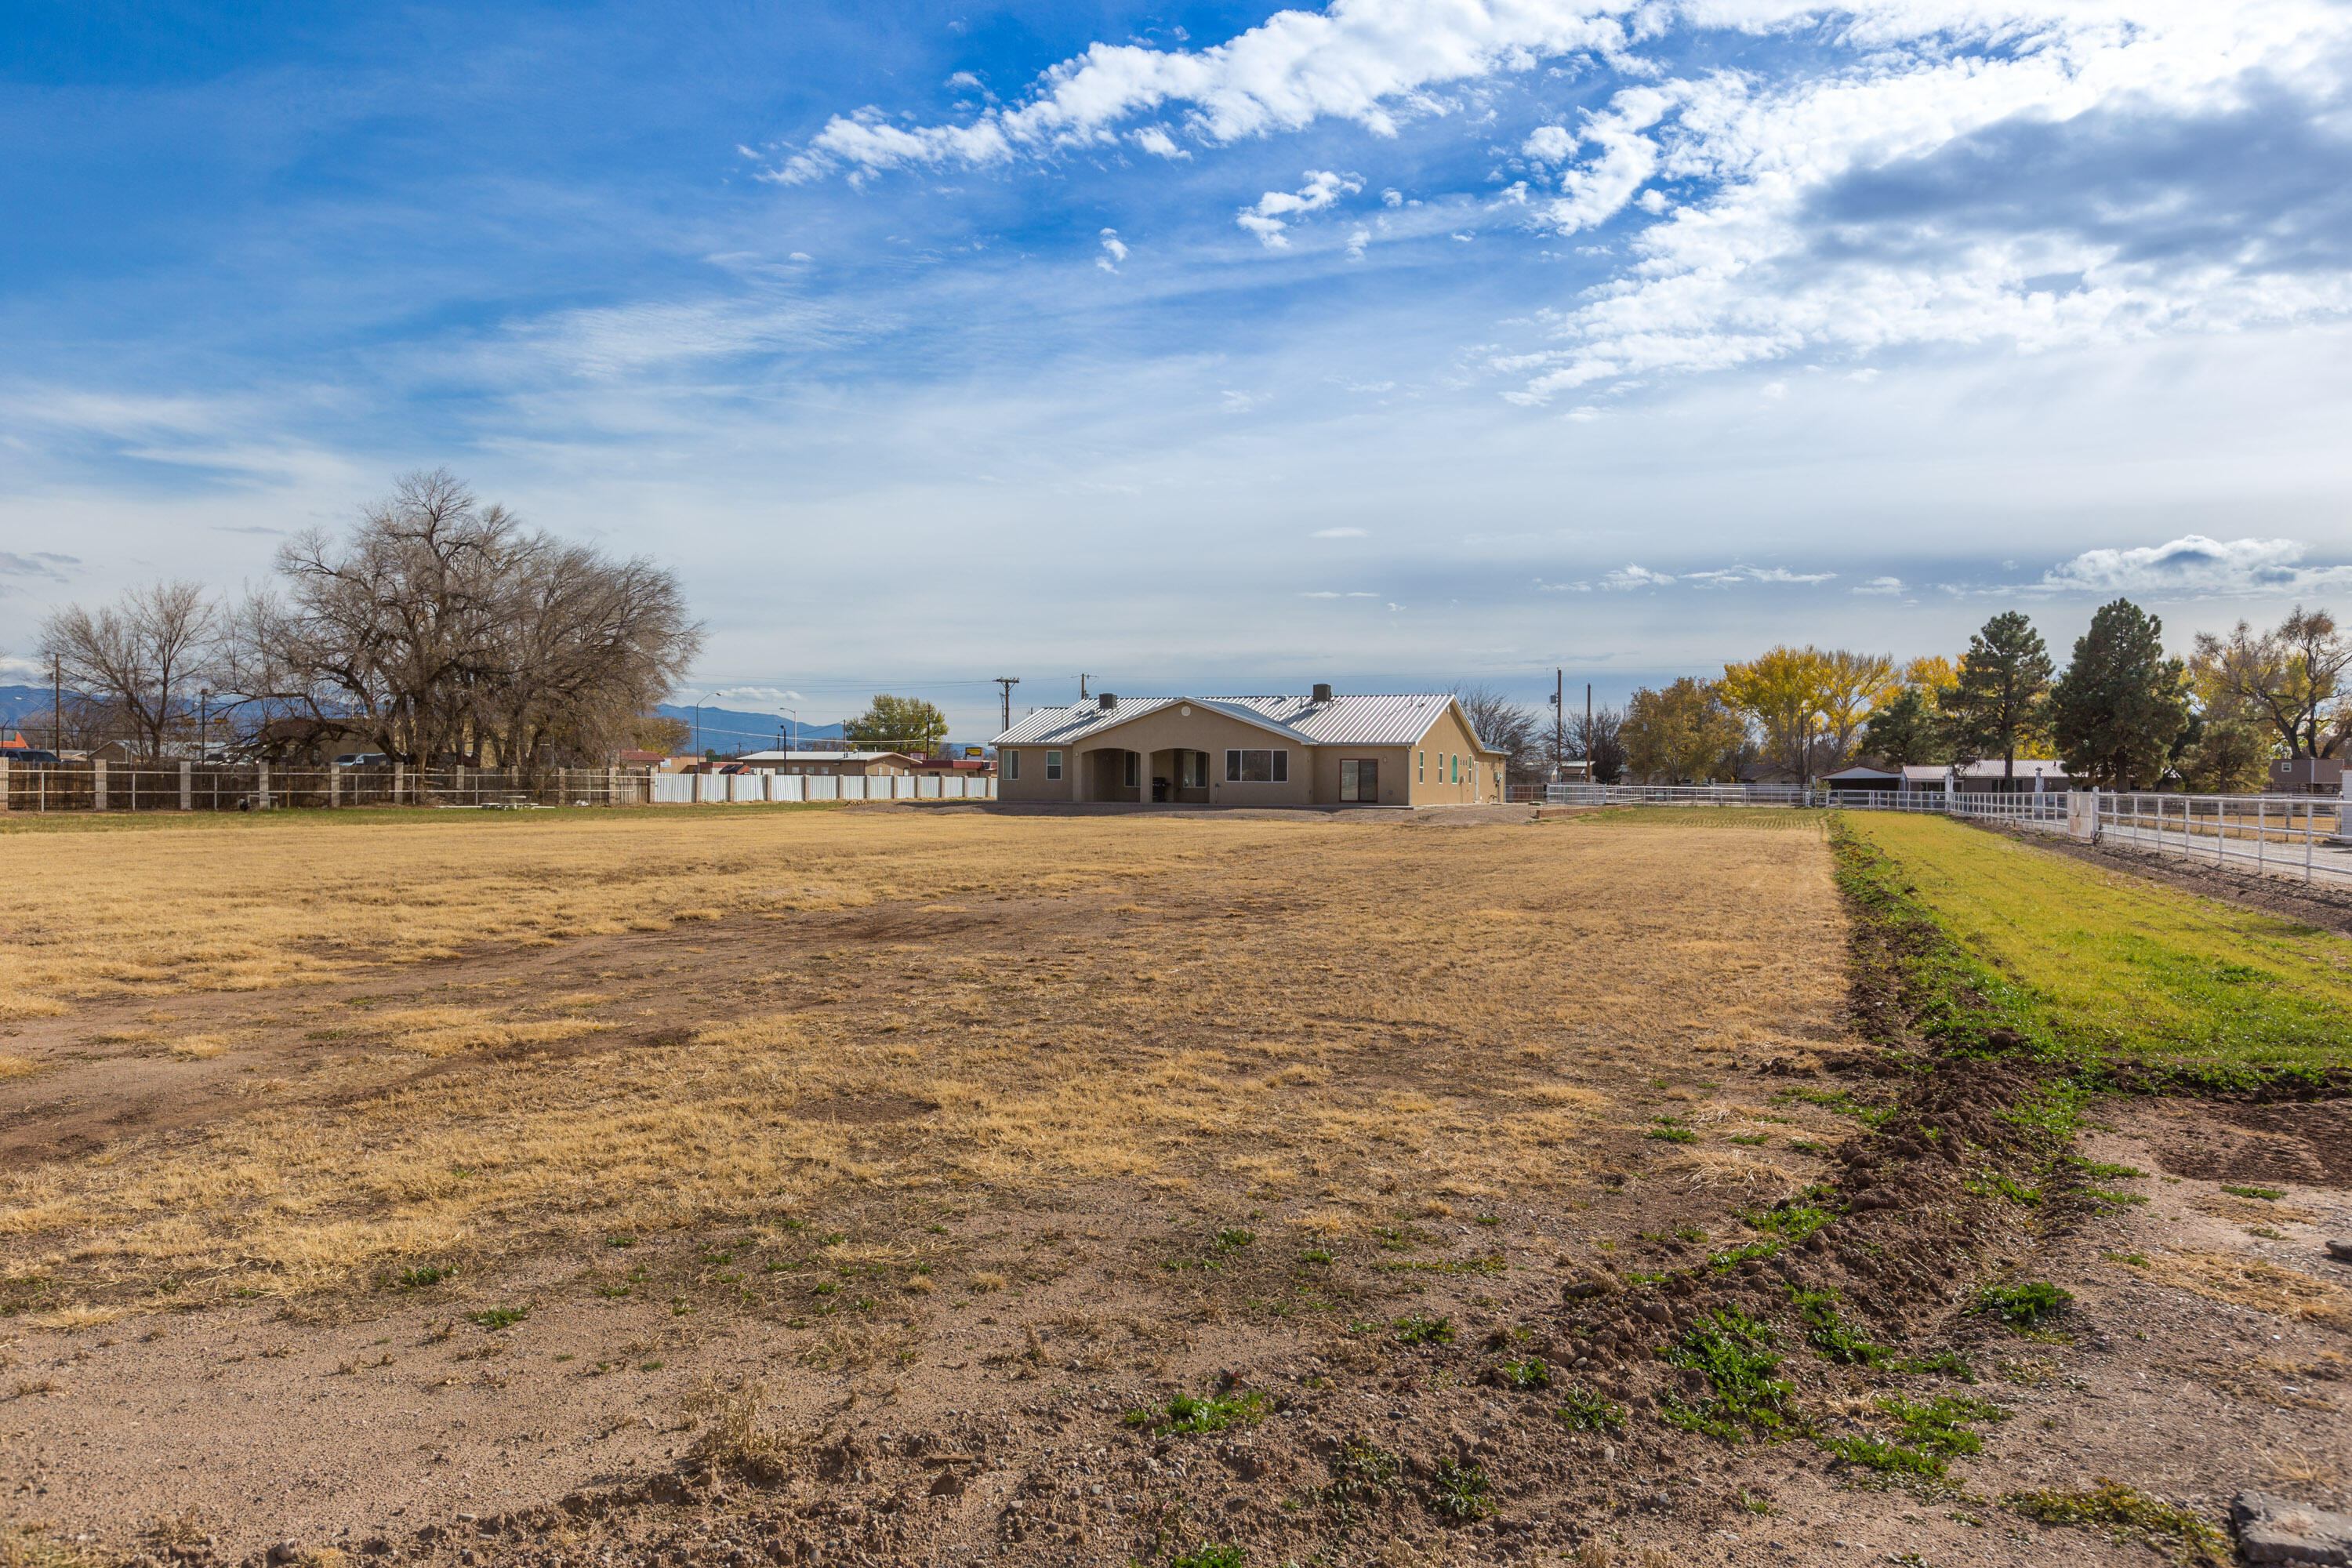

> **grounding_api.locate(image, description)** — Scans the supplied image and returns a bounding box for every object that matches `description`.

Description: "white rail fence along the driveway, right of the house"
[1545,785,2352,881]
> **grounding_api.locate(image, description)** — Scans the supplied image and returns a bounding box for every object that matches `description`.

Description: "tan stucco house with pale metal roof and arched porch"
[995,687,1508,806]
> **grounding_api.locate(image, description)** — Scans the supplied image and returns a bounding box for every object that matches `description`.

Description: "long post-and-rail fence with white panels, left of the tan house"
[0,757,997,813]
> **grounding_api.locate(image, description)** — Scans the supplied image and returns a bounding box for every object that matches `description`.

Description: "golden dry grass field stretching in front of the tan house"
[0,811,1842,1316]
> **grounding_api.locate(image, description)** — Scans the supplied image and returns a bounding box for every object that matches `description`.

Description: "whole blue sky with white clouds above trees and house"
[0,0,2352,731]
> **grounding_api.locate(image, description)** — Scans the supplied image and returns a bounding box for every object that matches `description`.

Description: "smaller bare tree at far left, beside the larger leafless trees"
[40,583,221,760]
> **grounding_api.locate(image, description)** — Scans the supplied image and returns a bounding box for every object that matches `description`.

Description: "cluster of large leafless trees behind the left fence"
[38,470,703,767]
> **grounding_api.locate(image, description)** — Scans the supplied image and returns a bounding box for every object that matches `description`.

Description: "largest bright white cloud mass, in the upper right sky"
[1510,0,2352,402]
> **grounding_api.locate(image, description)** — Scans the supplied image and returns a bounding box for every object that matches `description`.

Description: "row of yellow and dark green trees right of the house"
[1458,600,2352,792]
